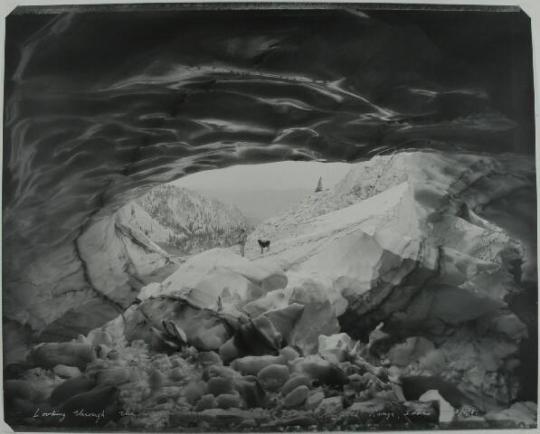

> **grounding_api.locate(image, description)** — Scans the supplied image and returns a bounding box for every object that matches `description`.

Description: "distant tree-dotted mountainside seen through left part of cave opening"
[121,185,250,255]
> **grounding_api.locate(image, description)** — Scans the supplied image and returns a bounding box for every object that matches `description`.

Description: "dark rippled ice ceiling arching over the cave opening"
[3,7,534,350]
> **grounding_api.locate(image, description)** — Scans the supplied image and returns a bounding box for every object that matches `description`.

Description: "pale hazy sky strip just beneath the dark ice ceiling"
[173,161,351,191]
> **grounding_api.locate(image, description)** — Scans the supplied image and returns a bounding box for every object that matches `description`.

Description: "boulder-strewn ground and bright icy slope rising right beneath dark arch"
[4,153,537,431]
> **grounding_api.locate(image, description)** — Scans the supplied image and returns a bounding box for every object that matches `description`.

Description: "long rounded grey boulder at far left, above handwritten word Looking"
[29,342,96,369]
